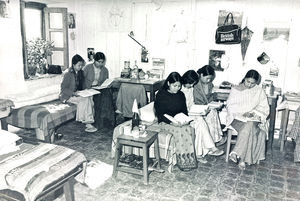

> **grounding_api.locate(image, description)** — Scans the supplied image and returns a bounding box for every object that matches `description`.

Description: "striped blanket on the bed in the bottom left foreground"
[0,143,86,201]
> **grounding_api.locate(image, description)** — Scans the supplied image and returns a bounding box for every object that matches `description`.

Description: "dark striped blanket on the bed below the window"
[6,100,77,137]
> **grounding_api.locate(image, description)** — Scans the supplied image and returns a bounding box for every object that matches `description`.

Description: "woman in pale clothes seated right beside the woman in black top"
[181,70,224,163]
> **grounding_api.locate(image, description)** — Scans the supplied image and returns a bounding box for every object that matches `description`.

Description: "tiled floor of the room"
[10,121,300,201]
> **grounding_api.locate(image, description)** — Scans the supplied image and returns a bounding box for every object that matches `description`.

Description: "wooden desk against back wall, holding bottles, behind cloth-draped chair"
[114,78,164,102]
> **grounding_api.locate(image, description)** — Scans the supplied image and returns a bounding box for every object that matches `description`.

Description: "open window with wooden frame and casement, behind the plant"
[20,1,69,79]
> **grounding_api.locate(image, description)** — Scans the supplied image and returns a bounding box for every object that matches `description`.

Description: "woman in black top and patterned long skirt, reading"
[154,72,197,172]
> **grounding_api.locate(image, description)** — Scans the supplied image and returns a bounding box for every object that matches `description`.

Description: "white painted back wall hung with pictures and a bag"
[0,0,300,97]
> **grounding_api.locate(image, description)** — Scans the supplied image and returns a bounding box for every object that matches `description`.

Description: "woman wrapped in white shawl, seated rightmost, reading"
[226,70,269,170]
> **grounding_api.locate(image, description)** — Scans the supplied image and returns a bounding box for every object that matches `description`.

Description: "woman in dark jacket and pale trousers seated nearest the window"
[59,54,97,132]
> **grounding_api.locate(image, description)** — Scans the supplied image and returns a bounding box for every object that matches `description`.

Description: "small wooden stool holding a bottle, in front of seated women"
[113,131,160,185]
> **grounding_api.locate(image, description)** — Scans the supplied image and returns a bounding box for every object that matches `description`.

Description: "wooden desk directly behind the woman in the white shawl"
[214,89,278,149]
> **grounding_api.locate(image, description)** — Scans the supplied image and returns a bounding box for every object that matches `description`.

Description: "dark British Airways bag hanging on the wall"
[215,13,241,44]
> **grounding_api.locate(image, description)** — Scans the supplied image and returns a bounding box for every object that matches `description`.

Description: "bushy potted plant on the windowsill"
[26,38,54,76]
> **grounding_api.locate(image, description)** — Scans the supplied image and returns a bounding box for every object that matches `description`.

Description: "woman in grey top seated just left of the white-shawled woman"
[193,65,226,146]
